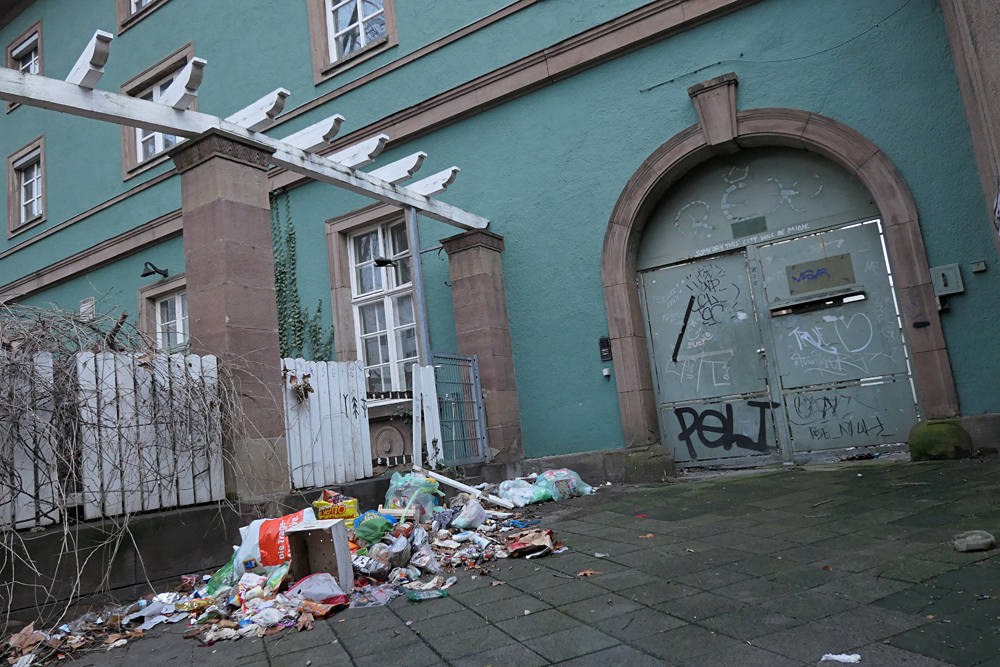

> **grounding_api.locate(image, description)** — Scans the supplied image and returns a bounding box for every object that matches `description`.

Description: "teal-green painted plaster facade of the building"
[0,0,1000,457]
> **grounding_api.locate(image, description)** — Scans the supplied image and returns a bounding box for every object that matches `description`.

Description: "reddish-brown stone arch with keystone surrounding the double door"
[601,105,958,447]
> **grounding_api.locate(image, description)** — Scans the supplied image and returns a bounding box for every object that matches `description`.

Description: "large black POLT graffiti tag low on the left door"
[673,400,780,459]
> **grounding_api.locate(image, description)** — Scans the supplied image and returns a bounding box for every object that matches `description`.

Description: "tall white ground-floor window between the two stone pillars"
[348,221,419,392]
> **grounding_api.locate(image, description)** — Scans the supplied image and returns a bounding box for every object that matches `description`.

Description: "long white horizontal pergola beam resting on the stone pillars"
[0,67,489,229]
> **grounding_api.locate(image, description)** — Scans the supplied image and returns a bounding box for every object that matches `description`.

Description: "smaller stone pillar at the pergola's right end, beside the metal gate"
[441,230,524,463]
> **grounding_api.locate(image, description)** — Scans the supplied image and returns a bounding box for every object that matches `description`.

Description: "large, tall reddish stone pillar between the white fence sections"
[171,130,289,499]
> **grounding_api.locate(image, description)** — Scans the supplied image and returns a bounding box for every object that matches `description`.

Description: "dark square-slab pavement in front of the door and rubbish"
[76,460,1000,667]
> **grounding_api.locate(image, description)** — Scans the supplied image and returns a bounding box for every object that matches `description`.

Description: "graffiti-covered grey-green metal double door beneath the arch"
[639,220,919,464]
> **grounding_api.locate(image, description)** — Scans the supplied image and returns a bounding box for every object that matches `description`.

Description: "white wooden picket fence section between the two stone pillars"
[281,359,372,489]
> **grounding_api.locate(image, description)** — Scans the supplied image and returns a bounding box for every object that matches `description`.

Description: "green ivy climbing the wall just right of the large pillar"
[271,190,333,361]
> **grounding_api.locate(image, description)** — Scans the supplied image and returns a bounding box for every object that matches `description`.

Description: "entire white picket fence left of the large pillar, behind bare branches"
[0,352,225,528]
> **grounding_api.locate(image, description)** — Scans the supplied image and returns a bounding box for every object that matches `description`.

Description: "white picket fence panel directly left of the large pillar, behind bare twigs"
[76,353,226,519]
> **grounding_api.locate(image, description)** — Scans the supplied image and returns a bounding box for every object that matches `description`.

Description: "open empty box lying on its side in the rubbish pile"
[285,519,354,596]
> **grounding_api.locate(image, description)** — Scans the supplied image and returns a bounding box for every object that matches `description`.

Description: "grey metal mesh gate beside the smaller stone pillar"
[432,352,489,466]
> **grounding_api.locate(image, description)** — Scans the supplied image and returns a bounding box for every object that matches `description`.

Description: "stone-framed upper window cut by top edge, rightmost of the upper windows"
[307,0,398,83]
